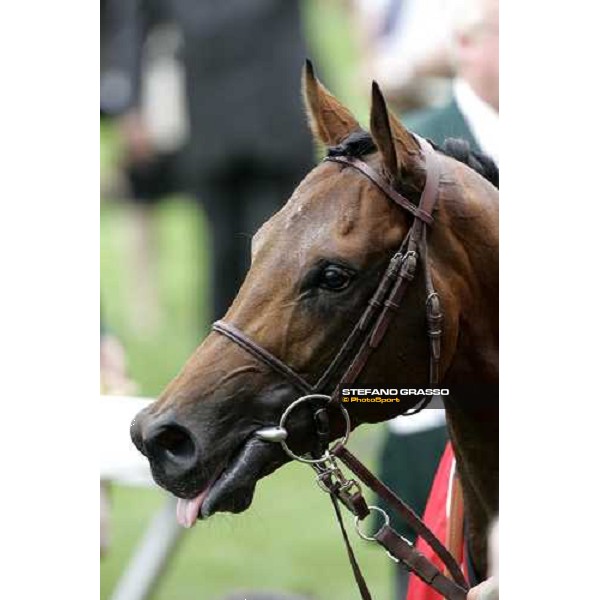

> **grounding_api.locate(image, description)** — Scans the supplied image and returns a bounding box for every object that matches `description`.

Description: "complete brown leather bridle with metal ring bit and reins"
[212,137,469,600]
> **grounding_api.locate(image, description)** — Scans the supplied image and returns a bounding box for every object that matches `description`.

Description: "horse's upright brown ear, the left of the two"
[302,60,360,146]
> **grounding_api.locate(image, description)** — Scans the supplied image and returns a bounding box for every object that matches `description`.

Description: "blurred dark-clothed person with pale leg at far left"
[100,0,187,335]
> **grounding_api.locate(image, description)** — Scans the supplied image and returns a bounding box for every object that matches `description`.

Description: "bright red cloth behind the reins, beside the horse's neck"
[407,443,467,600]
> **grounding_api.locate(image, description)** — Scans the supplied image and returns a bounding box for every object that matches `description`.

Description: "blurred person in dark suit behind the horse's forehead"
[105,0,313,328]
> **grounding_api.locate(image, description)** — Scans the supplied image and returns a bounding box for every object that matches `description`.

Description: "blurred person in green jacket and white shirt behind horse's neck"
[380,0,499,600]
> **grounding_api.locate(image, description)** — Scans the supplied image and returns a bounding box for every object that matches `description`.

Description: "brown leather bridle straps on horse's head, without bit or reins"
[212,137,443,414]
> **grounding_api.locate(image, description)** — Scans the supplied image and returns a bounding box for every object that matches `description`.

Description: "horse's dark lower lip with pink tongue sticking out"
[176,437,285,528]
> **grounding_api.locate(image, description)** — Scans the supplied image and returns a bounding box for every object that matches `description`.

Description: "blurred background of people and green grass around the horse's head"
[100,0,498,600]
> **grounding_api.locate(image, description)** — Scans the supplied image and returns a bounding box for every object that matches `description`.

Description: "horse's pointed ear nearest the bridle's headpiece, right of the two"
[371,81,420,180]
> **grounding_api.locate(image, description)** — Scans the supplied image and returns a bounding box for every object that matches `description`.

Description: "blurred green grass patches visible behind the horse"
[100,0,392,600]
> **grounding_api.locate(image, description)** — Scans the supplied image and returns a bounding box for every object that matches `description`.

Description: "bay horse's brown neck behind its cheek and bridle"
[444,168,498,576]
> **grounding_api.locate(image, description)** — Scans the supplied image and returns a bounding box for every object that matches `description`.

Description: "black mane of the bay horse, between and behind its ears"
[327,130,500,188]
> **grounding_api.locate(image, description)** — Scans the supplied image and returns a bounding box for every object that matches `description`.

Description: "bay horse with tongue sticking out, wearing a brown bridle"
[131,62,498,592]
